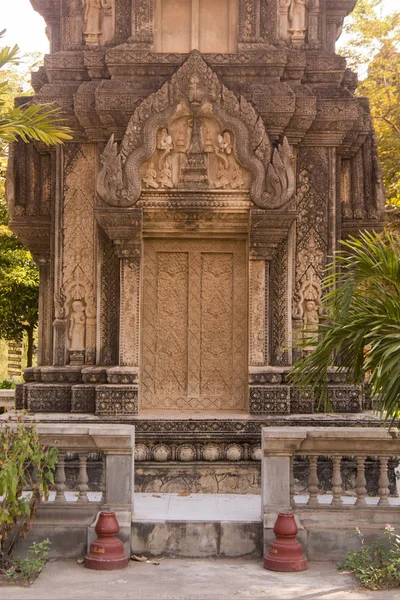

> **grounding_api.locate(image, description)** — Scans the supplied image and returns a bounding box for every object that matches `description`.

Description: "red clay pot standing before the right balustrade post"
[264,512,308,573]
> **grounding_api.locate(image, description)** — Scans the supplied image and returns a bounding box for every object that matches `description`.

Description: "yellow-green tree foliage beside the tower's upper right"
[341,0,400,205]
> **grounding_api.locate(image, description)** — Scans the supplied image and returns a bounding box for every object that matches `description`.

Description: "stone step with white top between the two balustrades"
[131,494,263,558]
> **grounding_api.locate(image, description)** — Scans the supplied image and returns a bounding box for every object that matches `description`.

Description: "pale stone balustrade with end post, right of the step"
[262,427,400,521]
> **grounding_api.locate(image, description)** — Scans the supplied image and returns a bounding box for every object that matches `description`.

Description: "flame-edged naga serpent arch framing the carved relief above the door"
[97,51,295,208]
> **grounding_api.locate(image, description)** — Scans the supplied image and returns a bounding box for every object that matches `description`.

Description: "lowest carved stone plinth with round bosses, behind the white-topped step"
[22,410,379,494]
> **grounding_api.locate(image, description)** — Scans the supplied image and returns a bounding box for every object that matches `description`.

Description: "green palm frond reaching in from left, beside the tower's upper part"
[0,104,71,145]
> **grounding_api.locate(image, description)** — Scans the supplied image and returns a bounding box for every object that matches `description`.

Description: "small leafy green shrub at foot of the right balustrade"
[339,523,400,590]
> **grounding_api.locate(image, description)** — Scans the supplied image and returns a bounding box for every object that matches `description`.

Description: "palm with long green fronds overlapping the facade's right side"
[291,231,400,426]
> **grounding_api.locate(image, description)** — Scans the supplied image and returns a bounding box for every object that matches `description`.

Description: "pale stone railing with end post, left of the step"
[17,423,134,557]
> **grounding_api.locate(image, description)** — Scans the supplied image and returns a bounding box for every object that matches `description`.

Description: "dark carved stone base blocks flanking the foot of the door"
[16,367,365,417]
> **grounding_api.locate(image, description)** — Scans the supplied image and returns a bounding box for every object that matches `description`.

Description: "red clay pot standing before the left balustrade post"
[85,512,129,571]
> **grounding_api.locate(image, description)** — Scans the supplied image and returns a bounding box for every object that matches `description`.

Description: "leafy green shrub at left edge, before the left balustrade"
[0,416,57,569]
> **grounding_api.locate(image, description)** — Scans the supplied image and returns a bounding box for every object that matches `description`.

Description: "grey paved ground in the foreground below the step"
[0,559,400,600]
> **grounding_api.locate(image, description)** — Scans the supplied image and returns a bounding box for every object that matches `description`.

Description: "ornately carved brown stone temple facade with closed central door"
[7,0,384,492]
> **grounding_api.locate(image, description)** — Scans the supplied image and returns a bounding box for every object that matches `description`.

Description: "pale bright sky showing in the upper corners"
[0,0,399,53]
